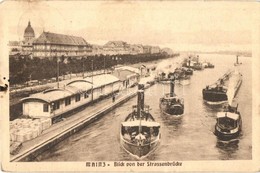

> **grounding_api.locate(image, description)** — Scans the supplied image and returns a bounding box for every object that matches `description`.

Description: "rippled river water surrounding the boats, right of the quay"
[37,54,252,161]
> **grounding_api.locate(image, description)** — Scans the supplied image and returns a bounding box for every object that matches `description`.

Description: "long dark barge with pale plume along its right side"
[202,71,242,104]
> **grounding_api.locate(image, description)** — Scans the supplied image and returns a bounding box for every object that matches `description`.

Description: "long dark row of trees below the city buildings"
[9,53,177,85]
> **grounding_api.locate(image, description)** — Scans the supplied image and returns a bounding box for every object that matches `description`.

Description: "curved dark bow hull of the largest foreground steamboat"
[120,136,160,159]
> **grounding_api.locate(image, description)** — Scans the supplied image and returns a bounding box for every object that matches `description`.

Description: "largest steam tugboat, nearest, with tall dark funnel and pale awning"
[120,84,160,159]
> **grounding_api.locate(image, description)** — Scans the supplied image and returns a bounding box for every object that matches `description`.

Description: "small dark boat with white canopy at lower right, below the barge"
[214,105,242,141]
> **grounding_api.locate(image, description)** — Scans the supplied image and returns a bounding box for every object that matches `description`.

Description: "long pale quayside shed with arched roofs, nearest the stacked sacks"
[22,74,122,118]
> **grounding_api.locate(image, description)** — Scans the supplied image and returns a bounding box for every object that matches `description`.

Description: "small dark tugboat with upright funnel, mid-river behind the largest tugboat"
[160,78,184,118]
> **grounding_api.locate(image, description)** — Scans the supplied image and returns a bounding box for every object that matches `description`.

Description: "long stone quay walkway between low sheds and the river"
[10,84,150,162]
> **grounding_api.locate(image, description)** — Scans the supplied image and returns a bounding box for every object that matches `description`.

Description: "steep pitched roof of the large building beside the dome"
[33,32,89,46]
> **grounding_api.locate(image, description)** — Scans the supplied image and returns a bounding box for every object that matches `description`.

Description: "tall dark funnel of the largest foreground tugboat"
[137,84,144,133]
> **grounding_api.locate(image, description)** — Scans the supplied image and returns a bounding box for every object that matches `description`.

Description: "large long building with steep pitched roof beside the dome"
[33,32,92,58]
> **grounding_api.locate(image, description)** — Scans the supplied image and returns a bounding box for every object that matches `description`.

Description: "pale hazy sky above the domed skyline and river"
[1,1,255,50]
